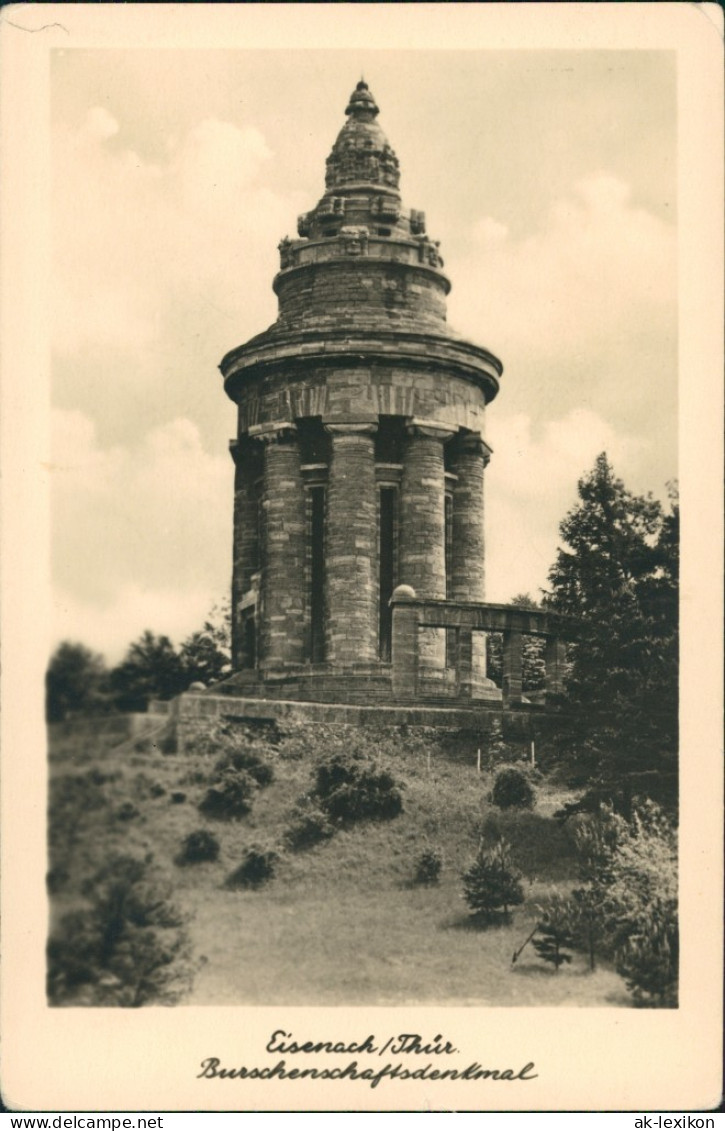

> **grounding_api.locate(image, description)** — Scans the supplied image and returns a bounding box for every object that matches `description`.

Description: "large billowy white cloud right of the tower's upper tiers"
[449,173,677,435]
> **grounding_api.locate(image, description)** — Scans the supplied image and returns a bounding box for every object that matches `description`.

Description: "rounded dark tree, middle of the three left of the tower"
[110,629,189,711]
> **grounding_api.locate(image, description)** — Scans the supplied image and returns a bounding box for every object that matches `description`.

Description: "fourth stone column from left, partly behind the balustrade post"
[399,421,451,673]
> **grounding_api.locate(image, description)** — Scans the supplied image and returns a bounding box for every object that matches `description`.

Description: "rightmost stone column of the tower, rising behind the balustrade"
[448,432,493,697]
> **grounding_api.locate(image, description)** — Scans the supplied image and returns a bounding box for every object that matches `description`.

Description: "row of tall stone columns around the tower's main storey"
[233,421,487,668]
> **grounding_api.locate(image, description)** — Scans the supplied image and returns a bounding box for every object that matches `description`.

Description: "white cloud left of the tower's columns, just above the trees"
[50,411,233,653]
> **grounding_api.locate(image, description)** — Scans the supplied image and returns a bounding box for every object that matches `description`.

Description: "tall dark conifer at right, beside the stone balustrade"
[546,454,679,811]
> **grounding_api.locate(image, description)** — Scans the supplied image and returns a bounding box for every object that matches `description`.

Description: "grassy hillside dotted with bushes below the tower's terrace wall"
[46,726,630,1005]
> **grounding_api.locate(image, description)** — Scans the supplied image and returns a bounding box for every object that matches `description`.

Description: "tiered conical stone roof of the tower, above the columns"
[222,72,501,415]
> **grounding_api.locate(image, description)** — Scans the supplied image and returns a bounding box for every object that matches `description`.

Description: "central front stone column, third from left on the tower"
[325,423,378,664]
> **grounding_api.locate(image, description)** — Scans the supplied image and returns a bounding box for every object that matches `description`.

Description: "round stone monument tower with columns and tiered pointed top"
[221,81,502,702]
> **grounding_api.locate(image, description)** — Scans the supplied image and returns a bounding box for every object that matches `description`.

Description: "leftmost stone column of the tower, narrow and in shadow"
[230,435,261,671]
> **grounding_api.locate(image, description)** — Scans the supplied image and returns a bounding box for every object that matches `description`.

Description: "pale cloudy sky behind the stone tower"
[51,50,677,662]
